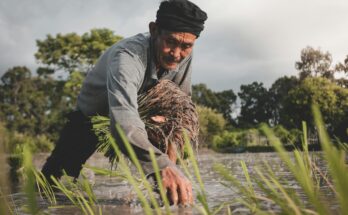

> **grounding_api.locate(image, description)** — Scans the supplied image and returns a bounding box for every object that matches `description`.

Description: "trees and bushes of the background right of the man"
[192,47,348,148]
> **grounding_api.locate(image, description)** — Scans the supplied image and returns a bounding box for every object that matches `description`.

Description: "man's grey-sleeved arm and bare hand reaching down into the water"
[107,51,193,204]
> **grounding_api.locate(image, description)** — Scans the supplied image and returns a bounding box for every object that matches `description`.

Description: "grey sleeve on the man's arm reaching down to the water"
[107,50,171,174]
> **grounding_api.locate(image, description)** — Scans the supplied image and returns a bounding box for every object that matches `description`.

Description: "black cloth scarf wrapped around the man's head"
[156,0,208,37]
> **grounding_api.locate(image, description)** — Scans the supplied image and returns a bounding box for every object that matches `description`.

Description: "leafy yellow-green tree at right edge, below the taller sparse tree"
[288,77,348,141]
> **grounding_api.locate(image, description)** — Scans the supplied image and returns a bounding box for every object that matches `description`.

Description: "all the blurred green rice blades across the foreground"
[0,107,348,215]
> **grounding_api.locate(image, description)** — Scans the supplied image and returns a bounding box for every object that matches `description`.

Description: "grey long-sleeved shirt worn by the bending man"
[77,33,192,174]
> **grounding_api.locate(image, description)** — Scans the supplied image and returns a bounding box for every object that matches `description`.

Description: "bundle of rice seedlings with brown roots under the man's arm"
[92,80,199,163]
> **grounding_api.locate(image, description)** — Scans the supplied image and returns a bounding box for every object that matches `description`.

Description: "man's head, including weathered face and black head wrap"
[149,0,207,70]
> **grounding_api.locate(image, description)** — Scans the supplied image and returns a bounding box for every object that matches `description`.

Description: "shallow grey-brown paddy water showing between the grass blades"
[7,151,331,215]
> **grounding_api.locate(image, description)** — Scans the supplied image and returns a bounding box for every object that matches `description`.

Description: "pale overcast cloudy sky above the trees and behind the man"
[0,0,348,91]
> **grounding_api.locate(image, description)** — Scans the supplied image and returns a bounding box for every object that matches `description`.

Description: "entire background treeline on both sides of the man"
[0,29,348,151]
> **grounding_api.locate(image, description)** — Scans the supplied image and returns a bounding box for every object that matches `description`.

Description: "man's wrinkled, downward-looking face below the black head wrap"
[155,30,197,70]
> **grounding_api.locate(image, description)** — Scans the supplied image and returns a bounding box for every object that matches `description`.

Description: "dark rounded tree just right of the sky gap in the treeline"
[238,82,272,127]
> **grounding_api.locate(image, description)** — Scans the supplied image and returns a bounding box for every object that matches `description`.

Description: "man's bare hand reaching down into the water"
[161,165,193,205]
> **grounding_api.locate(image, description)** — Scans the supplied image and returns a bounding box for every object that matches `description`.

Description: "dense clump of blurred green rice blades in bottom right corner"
[214,103,348,214]
